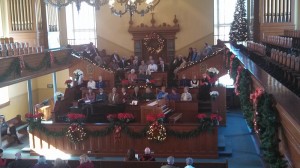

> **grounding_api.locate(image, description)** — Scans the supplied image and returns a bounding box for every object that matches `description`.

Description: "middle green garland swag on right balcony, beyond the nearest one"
[238,69,253,129]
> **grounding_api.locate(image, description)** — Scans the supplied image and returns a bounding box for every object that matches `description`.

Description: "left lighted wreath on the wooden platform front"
[66,123,86,144]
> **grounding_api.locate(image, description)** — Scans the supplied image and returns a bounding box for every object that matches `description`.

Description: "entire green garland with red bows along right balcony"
[230,50,286,168]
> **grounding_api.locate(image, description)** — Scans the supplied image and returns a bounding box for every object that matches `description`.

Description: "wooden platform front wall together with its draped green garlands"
[29,123,218,159]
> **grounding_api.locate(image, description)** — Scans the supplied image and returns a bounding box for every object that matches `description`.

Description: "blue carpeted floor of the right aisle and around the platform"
[3,110,264,168]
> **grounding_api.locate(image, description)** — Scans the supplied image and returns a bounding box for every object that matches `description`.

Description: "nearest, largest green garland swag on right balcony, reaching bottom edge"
[258,93,286,168]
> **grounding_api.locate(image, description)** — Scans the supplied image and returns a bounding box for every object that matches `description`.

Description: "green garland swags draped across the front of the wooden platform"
[29,122,212,139]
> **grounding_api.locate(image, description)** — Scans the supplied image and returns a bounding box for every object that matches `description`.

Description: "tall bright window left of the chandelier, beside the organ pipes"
[66,3,96,45]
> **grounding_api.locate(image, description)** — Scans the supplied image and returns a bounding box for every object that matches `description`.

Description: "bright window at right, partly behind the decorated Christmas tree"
[214,0,237,43]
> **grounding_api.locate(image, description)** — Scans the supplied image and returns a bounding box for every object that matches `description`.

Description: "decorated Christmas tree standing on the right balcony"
[229,0,248,41]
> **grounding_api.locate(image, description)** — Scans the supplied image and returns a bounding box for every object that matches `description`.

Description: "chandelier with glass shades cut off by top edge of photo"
[108,0,160,17]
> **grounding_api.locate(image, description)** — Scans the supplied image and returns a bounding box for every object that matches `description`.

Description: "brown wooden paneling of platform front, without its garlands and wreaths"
[29,123,218,158]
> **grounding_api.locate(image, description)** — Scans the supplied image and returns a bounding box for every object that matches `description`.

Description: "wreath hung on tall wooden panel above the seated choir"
[144,33,165,54]
